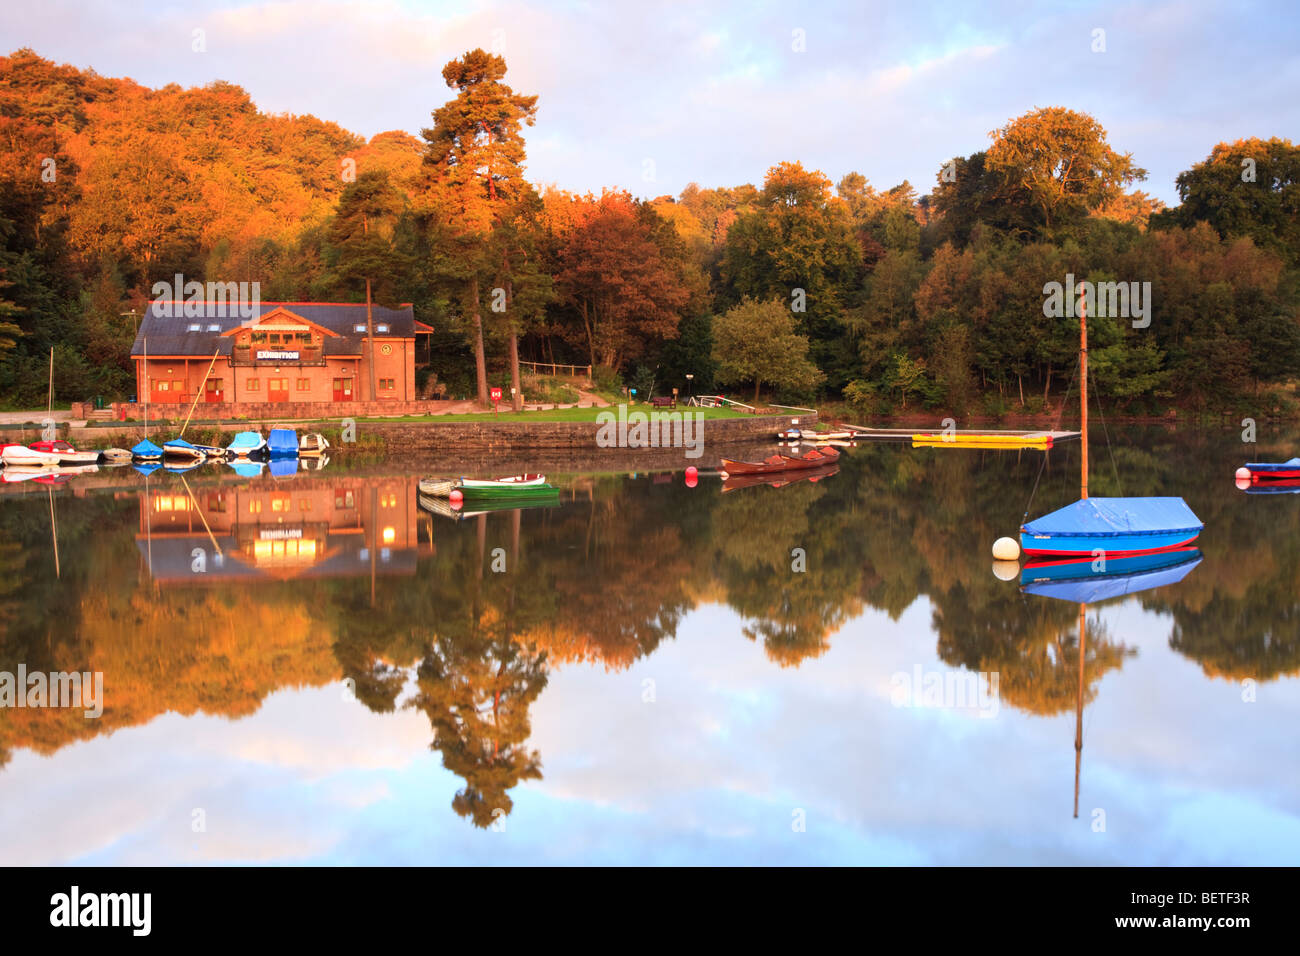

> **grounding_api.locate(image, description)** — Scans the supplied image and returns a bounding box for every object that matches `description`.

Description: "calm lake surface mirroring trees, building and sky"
[0,427,1300,865]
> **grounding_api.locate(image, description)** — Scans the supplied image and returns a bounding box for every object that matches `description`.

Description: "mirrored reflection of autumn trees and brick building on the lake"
[0,434,1300,848]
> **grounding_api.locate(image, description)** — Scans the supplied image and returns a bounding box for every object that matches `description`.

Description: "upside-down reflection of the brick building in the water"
[135,475,432,584]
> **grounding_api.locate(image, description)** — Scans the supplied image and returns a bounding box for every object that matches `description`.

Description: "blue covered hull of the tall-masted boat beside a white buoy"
[1021,498,1205,557]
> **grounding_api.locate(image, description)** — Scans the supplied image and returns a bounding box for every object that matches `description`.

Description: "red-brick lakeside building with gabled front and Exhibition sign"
[131,299,433,415]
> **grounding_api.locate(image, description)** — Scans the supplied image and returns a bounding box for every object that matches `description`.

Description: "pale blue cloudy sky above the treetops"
[0,0,1300,202]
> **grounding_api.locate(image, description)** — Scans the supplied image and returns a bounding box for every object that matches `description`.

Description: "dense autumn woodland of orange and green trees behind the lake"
[0,49,1300,416]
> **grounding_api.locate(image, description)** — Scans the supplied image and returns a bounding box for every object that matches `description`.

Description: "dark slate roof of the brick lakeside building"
[131,299,416,358]
